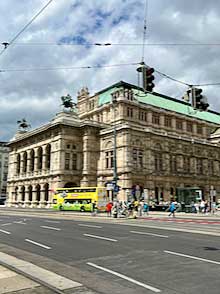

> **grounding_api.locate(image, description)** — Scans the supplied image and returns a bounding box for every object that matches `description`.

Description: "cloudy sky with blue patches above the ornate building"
[0,0,220,141]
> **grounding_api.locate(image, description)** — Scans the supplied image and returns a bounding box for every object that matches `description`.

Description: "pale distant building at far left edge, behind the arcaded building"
[0,142,9,204]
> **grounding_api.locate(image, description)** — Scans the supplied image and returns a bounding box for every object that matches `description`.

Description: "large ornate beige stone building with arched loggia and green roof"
[8,82,220,206]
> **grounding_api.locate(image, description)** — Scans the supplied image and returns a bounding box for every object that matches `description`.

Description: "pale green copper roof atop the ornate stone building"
[97,82,220,124]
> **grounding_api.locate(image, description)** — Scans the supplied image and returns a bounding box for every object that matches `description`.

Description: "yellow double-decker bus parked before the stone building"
[53,187,108,211]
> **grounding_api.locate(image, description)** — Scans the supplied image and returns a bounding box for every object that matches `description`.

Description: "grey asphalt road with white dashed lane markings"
[0,215,220,294]
